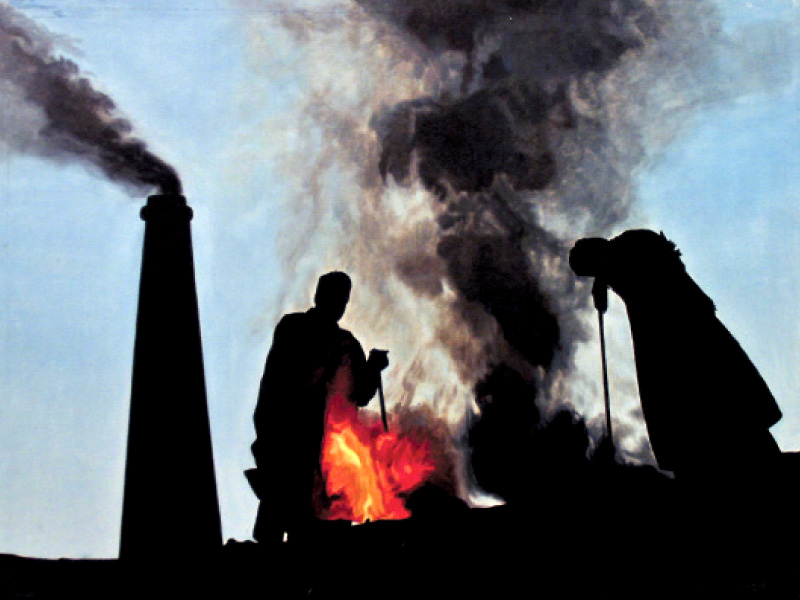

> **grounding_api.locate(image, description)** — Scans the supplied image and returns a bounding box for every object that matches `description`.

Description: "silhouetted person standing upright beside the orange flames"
[252,271,389,544]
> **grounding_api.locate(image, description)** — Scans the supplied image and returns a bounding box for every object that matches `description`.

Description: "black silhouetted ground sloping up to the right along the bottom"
[0,462,800,600]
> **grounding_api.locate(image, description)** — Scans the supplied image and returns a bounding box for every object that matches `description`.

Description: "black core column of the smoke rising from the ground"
[360,0,692,503]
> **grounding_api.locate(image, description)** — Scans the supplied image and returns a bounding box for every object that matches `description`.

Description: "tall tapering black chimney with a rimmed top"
[119,195,222,560]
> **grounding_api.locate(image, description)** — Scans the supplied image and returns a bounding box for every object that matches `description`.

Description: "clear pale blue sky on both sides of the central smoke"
[0,0,800,557]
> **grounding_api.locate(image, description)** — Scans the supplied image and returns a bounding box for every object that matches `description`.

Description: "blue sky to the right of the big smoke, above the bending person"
[639,7,800,450]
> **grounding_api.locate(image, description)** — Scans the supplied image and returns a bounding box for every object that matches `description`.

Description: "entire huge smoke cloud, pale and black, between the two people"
[239,0,717,504]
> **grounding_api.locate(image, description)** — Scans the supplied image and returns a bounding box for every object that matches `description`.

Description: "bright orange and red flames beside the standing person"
[321,393,435,523]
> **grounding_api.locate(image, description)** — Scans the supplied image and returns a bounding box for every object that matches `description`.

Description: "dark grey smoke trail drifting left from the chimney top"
[0,2,181,193]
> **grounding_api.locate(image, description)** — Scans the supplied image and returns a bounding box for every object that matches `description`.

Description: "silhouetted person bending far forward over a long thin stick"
[570,230,781,482]
